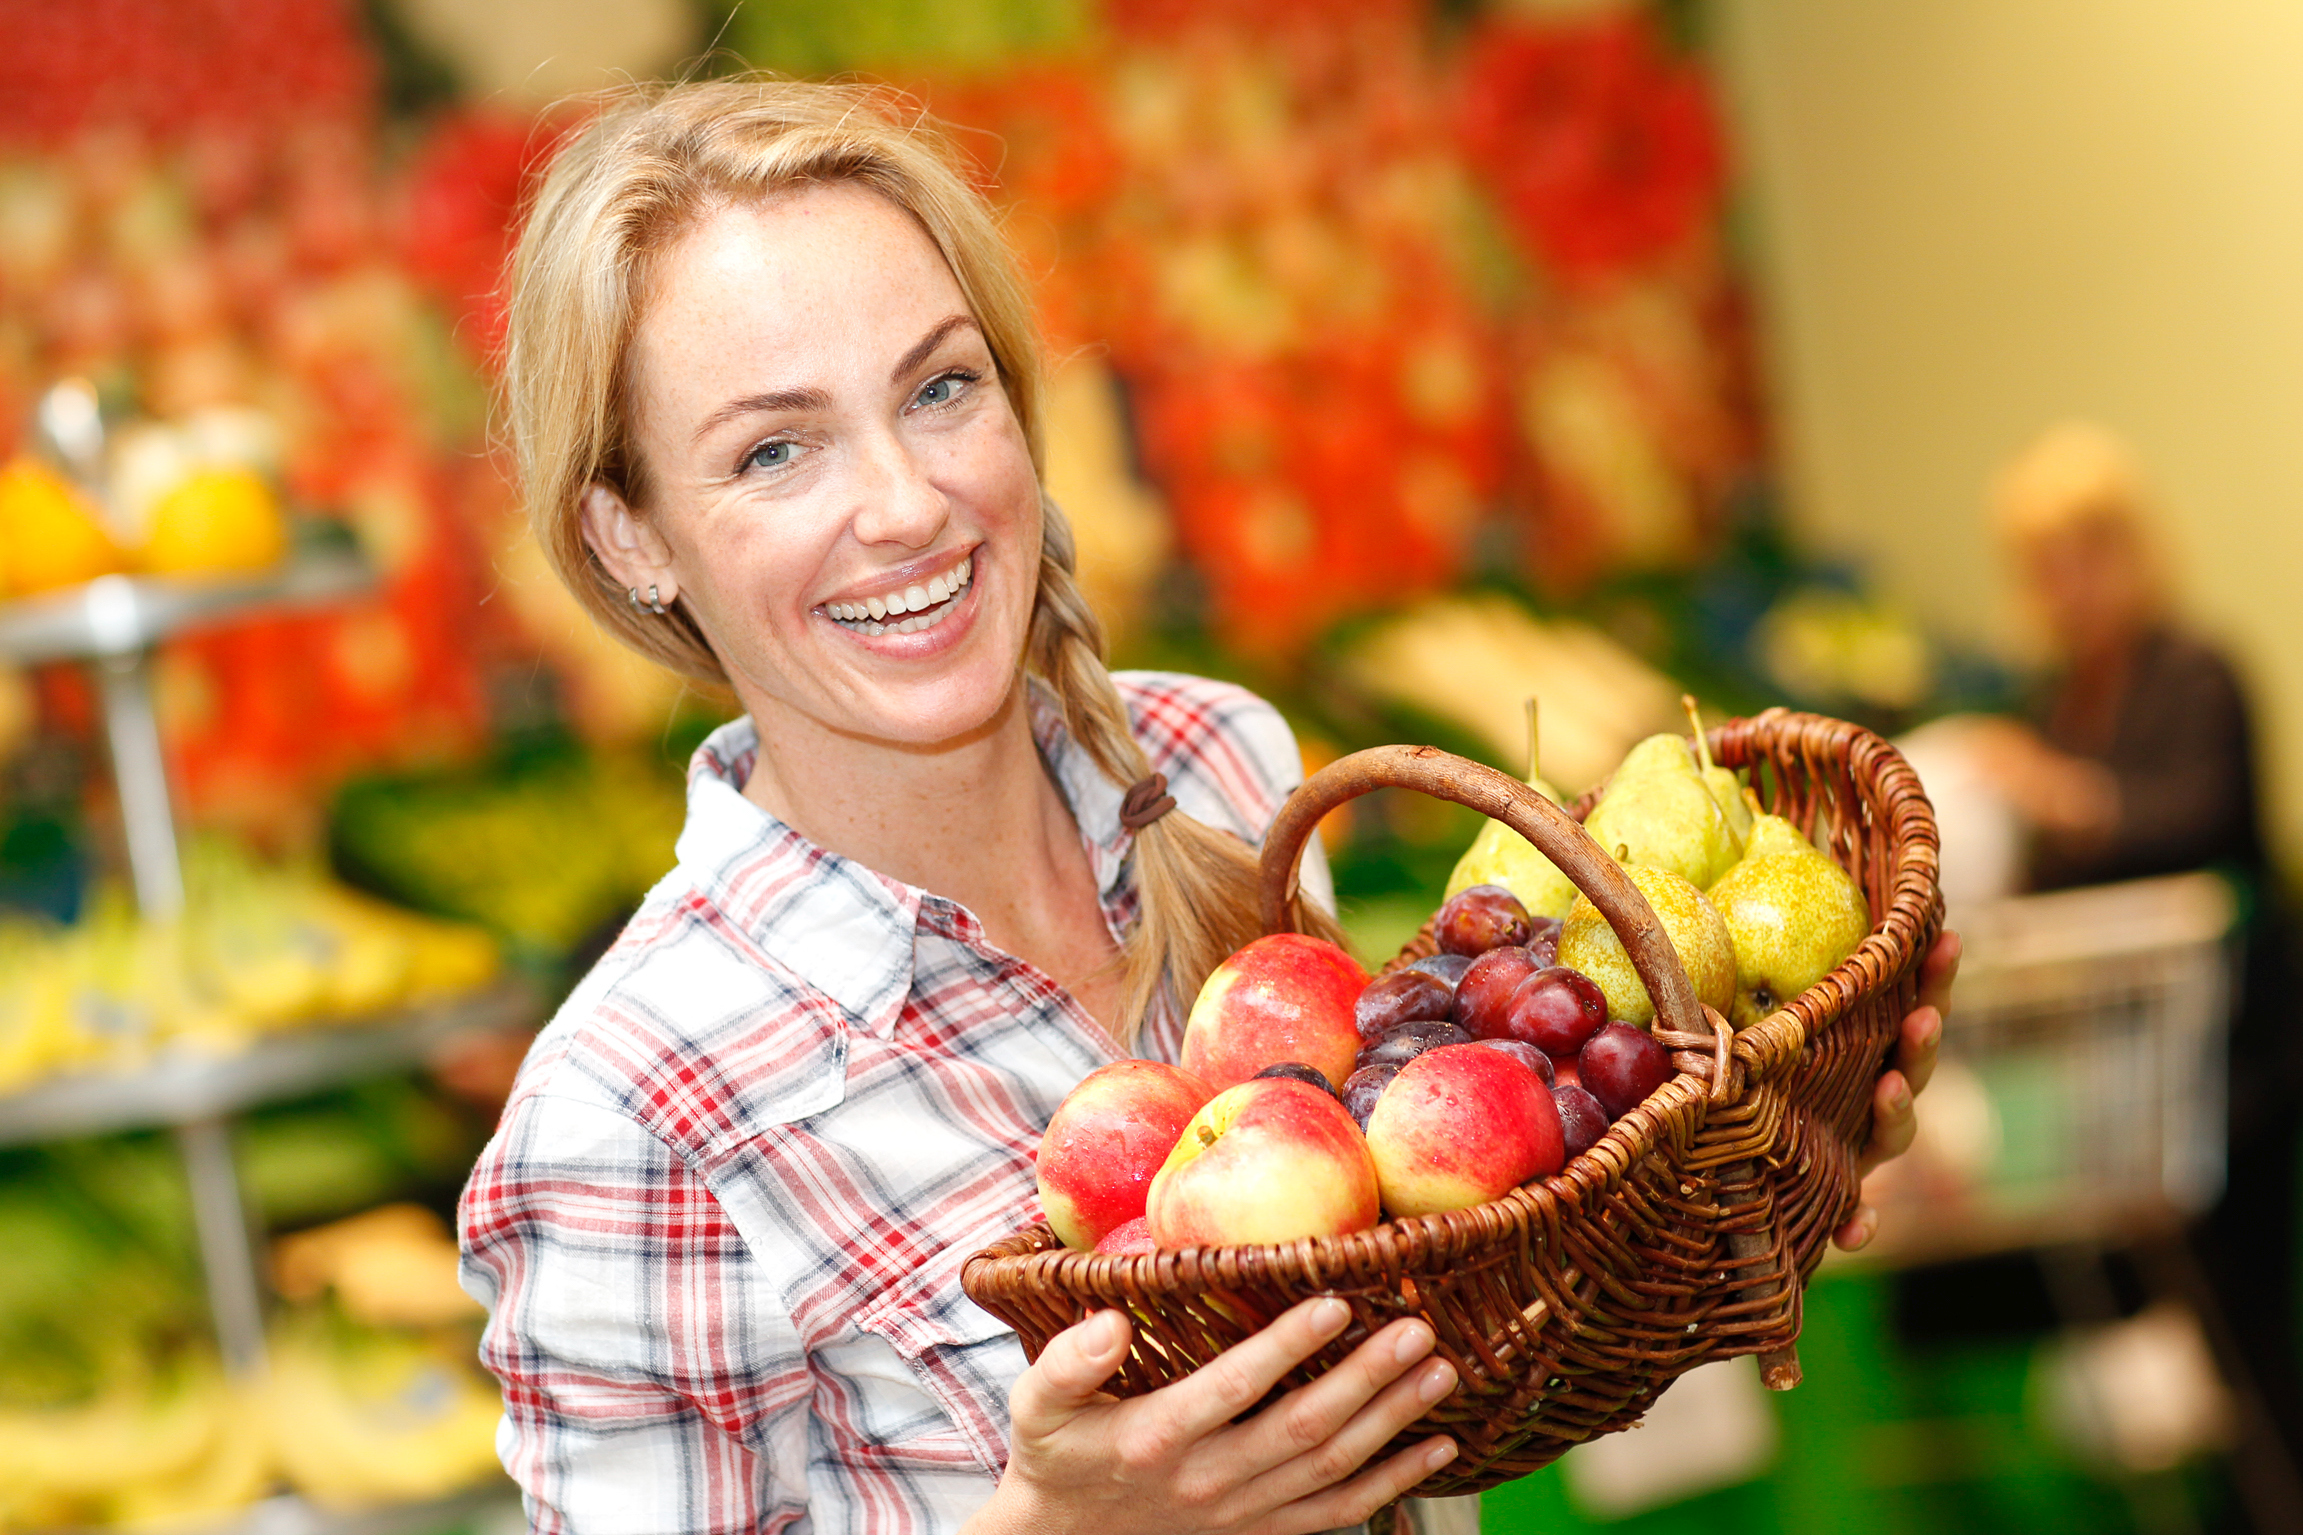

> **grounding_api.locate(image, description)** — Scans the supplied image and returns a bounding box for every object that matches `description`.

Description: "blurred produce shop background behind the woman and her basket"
[0,0,2303,1535]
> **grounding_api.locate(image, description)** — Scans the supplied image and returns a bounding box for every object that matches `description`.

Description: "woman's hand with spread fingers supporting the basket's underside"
[967,1298,1455,1535]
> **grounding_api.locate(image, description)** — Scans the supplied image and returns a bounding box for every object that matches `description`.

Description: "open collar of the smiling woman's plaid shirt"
[675,681,1135,1036]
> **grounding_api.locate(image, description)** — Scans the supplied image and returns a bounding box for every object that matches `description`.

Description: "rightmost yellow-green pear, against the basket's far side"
[1711,815,1870,1029]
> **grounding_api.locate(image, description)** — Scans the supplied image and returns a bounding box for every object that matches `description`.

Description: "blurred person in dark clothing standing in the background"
[1976,423,2303,1509]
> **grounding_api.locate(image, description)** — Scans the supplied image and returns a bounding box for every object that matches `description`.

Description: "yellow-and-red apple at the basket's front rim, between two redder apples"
[1145,1081,1381,1250]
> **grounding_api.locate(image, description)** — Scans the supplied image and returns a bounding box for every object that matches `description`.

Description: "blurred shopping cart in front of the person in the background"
[1865,875,2236,1263]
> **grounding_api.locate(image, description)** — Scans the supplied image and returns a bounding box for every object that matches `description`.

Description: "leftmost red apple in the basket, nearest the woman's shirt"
[1039,1061,1214,1247]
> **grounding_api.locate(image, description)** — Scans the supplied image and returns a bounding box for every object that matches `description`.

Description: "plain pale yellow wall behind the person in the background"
[1713,0,2303,863]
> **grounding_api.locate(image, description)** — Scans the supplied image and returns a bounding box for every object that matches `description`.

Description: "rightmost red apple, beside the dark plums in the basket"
[1363,1045,1566,1222]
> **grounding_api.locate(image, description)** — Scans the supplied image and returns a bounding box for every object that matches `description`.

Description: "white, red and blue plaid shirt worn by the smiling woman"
[461,672,1331,1535]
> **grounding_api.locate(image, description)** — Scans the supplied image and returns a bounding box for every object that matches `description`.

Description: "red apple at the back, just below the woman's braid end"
[1184,932,1368,1093]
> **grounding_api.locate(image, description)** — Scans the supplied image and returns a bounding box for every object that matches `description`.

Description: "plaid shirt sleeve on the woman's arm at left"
[458,1093,808,1535]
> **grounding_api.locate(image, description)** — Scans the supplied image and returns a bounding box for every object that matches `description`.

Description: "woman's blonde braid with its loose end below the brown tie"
[1025,497,1343,1045]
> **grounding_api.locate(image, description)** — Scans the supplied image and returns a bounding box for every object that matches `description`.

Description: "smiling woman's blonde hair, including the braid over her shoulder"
[504,78,1340,1043]
